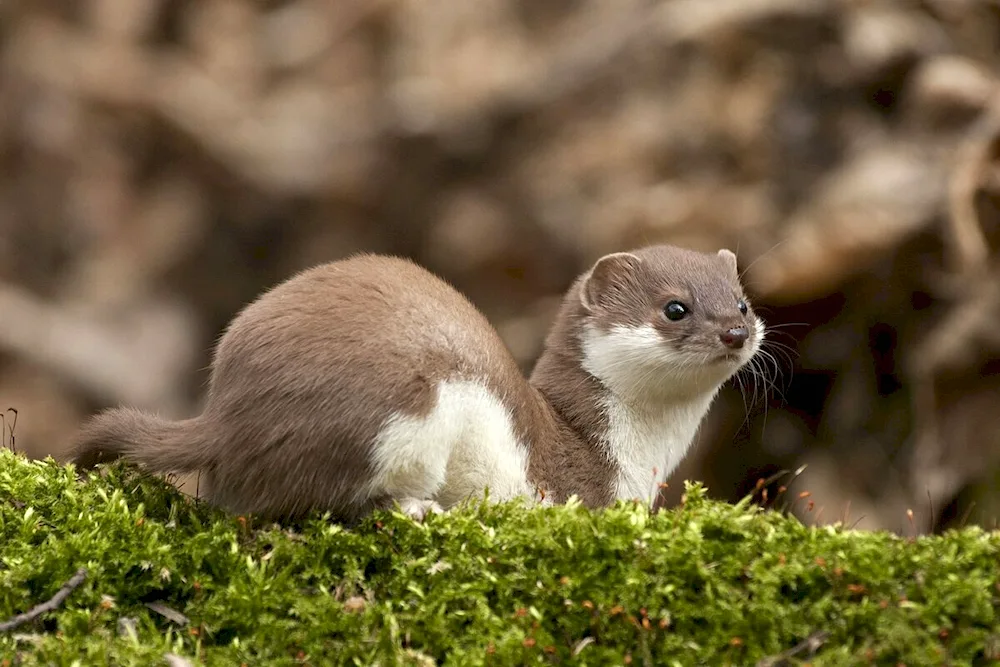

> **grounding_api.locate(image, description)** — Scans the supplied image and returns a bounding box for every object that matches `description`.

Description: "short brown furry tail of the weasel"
[71,408,212,472]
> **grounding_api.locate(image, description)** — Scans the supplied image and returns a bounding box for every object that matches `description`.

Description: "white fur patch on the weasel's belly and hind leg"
[359,381,533,509]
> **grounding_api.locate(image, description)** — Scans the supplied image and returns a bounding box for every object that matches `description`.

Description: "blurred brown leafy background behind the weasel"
[0,0,1000,534]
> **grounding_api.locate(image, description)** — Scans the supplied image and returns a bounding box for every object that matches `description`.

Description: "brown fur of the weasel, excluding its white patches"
[74,246,756,519]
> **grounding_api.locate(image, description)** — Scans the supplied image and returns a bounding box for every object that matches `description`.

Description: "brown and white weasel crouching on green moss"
[72,245,764,521]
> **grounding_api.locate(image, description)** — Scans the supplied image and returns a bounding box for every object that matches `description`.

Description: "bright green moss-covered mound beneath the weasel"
[0,452,1000,665]
